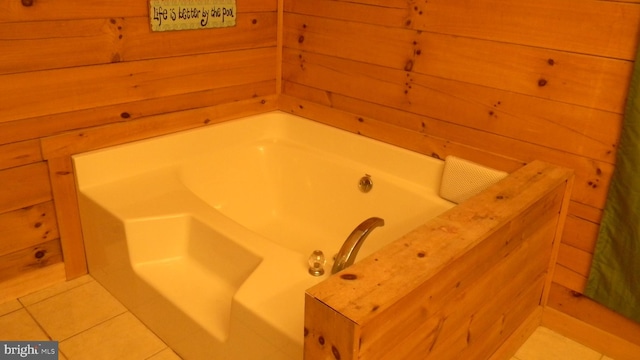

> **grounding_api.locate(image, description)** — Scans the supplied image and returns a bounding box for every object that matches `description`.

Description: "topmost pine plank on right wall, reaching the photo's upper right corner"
[412,0,640,60]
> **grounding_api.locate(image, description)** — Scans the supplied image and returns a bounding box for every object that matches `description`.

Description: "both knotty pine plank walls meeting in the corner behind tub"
[0,0,640,354]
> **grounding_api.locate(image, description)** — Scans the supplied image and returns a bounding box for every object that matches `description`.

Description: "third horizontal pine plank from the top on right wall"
[284,51,622,163]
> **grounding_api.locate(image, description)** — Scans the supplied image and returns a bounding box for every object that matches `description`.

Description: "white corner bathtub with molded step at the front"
[73,112,453,360]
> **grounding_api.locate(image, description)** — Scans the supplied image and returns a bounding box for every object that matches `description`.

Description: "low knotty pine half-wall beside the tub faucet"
[305,161,573,360]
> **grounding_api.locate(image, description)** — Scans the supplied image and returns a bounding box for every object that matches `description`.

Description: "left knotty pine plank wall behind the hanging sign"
[0,0,278,302]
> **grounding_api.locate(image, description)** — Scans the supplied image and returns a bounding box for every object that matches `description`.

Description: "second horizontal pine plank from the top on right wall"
[284,14,633,113]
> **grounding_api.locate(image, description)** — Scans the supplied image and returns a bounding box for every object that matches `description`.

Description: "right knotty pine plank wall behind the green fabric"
[279,0,640,352]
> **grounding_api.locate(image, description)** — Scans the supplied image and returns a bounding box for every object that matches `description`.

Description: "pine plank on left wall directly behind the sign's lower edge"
[0,12,277,75]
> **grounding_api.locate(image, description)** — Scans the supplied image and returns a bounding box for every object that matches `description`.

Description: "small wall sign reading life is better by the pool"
[149,0,237,31]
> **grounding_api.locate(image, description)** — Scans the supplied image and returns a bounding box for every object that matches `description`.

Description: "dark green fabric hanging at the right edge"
[585,42,640,322]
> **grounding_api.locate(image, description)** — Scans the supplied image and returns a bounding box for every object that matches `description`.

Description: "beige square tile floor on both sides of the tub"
[0,275,612,360]
